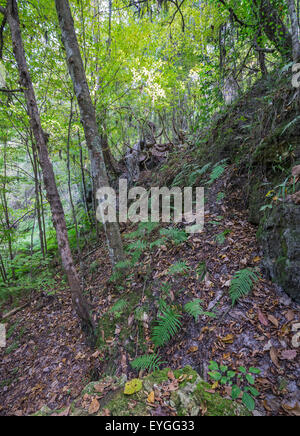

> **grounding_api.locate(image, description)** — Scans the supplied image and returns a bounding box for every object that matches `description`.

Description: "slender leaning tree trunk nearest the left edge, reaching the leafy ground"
[7,0,94,334]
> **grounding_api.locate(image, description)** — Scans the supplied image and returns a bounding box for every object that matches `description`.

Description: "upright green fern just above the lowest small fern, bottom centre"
[151,304,181,347]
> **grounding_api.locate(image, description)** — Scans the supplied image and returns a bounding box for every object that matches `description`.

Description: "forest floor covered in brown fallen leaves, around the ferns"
[0,168,300,416]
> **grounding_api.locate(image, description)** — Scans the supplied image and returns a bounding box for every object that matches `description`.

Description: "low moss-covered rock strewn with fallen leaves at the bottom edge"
[36,366,249,416]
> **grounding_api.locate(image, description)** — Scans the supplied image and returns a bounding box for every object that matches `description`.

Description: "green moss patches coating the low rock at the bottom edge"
[35,366,249,416]
